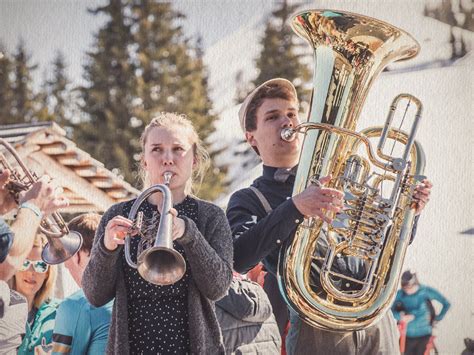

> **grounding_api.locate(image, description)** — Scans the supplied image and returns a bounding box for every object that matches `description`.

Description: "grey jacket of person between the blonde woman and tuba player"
[216,279,281,355]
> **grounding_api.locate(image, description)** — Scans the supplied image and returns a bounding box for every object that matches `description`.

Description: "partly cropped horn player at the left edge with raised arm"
[0,170,68,354]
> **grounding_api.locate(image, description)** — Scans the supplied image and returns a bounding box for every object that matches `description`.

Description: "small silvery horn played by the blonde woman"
[125,172,186,285]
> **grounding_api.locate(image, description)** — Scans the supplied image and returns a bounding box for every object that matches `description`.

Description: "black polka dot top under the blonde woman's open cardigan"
[122,196,197,354]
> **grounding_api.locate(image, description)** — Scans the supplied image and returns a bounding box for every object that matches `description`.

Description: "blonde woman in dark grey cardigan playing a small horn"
[82,113,233,355]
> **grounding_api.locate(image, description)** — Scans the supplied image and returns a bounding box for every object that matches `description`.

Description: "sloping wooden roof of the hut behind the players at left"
[0,122,140,213]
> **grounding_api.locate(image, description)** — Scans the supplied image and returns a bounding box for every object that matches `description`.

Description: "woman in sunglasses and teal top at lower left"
[11,233,59,354]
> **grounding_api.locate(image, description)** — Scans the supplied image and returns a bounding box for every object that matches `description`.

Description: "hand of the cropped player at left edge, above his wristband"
[19,176,69,216]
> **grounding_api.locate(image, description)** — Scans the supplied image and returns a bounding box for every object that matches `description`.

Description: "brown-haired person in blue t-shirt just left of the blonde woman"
[53,213,113,355]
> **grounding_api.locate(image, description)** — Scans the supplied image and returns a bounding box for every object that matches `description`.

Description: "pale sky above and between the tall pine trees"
[0,0,273,87]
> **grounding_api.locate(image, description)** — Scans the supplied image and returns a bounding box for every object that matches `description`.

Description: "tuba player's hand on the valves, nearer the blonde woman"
[293,176,344,223]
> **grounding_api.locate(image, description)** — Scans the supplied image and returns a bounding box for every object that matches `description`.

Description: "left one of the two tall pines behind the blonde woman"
[74,0,138,182]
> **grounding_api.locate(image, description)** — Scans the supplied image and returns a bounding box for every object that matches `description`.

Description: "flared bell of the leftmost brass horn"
[41,231,82,265]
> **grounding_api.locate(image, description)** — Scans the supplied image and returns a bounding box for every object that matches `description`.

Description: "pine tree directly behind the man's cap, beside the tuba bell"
[253,1,311,101]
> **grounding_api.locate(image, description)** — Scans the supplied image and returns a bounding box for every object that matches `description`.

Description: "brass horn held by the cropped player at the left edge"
[0,138,82,265]
